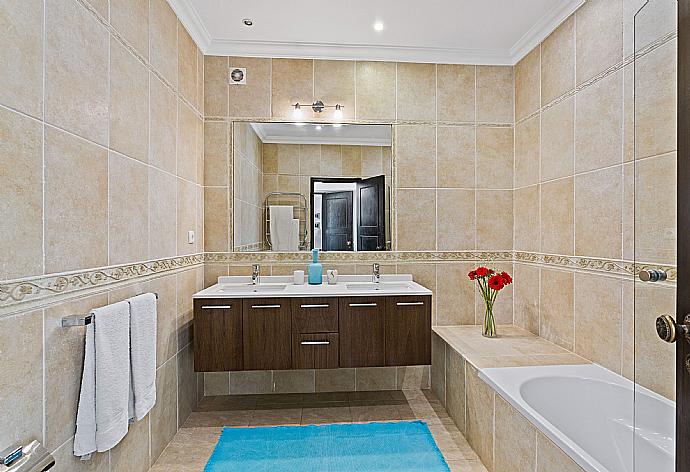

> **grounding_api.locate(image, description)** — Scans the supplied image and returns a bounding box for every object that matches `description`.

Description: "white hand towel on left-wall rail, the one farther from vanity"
[74,302,130,456]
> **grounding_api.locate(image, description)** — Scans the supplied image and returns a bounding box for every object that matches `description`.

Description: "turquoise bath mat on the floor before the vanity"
[204,421,450,472]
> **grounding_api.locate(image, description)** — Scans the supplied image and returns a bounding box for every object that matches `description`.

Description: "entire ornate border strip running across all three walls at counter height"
[0,251,677,315]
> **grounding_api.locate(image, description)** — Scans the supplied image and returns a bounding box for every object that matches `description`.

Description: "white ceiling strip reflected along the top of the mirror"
[251,123,392,146]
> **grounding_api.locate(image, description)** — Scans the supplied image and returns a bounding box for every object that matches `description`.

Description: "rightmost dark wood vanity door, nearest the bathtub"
[386,296,431,365]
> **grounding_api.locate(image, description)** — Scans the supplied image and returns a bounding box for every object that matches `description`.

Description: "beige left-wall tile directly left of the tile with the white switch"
[149,168,177,259]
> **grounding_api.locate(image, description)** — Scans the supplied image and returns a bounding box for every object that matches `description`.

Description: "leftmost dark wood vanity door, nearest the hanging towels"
[194,299,242,372]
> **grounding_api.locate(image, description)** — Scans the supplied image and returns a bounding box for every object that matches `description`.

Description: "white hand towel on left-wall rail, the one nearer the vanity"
[128,293,157,421]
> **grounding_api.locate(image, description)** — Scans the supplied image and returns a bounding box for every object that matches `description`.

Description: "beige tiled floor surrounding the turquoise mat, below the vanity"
[151,390,486,472]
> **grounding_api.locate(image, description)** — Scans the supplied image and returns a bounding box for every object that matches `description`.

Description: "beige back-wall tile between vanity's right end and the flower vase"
[435,263,476,326]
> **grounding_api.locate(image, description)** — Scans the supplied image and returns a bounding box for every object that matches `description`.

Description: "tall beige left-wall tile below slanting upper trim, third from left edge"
[110,39,149,162]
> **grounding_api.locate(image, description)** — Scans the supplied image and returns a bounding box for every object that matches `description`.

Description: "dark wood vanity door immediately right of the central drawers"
[338,297,385,367]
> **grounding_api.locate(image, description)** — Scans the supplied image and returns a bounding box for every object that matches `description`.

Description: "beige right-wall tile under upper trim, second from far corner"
[541,98,575,182]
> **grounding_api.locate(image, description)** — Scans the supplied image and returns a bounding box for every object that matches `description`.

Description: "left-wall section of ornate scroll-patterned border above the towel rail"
[0,254,204,315]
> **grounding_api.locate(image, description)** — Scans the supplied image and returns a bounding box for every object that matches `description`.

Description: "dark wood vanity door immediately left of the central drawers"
[242,298,292,370]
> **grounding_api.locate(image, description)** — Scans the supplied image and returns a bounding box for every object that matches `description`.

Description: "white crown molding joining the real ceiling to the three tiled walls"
[173,0,587,66]
